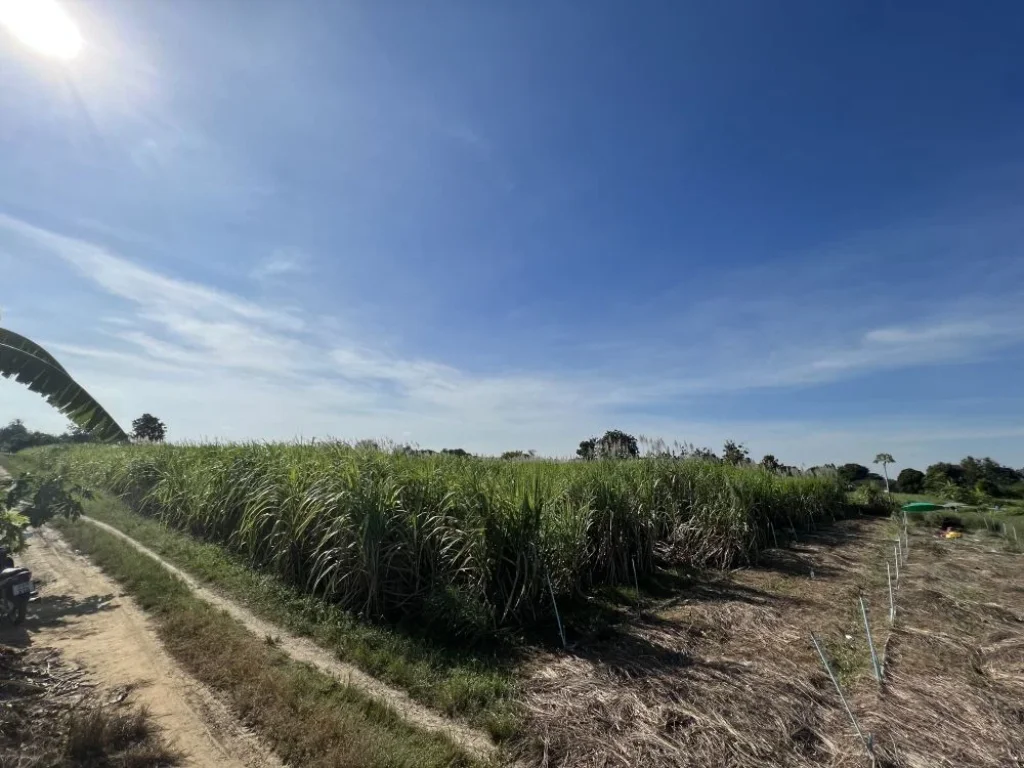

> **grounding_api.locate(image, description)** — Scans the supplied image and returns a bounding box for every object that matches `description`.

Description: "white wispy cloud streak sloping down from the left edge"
[0,216,578,436]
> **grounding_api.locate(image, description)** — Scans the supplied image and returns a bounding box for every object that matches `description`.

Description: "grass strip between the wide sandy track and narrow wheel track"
[59,521,475,768]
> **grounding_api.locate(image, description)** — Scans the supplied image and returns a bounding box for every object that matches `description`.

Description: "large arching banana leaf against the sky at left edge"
[0,328,128,441]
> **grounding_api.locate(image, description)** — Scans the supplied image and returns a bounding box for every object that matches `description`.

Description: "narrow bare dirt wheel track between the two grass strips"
[81,515,498,759]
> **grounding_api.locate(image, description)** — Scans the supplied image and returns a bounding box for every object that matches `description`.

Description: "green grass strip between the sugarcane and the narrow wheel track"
[70,492,521,740]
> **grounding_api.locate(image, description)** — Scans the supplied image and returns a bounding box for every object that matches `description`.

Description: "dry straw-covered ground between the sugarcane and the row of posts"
[520,520,881,768]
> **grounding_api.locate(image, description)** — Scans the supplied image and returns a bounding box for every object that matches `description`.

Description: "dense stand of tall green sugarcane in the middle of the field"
[37,444,846,636]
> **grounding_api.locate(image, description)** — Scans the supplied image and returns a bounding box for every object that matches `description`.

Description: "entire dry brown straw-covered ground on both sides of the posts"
[520,519,1024,768]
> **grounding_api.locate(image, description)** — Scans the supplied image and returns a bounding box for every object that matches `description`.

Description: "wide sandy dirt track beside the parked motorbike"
[0,528,281,768]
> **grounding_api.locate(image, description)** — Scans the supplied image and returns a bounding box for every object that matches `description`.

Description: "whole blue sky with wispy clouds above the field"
[0,0,1024,466]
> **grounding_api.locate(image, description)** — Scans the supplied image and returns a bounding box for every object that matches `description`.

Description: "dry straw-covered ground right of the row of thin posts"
[858,532,1024,768]
